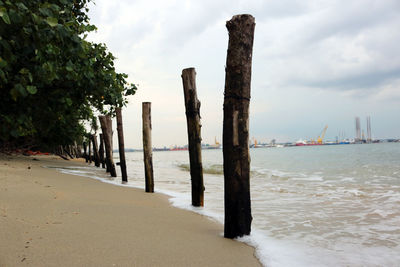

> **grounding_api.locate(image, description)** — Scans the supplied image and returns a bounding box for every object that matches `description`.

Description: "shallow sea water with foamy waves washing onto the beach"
[57,143,400,266]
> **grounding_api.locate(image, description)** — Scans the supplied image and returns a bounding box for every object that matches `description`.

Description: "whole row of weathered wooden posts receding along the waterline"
[84,15,255,241]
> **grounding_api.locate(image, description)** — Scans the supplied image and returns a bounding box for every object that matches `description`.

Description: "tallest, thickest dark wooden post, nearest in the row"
[223,15,255,238]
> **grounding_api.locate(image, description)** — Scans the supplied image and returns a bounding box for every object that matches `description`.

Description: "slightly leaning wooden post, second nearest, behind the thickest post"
[182,68,204,207]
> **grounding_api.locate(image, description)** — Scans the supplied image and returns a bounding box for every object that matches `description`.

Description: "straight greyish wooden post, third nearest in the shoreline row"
[142,102,154,193]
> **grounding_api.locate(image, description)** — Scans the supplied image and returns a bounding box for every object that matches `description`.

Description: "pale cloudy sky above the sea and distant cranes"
[89,0,400,148]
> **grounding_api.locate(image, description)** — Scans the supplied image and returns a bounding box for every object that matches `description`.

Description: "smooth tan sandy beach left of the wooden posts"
[0,154,260,267]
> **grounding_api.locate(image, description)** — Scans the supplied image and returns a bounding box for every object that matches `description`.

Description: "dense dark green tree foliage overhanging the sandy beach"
[0,0,137,150]
